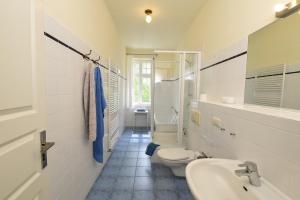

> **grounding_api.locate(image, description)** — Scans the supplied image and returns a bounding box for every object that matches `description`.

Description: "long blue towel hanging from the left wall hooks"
[93,67,106,163]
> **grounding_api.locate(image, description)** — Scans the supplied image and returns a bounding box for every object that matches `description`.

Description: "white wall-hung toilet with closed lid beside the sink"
[157,148,200,177]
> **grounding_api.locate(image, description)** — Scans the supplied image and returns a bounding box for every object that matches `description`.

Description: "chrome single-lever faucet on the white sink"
[234,161,261,187]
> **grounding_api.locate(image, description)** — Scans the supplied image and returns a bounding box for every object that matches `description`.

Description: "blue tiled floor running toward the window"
[86,130,193,200]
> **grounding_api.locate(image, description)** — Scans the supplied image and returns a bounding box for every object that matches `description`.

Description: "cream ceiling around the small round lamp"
[105,0,205,49]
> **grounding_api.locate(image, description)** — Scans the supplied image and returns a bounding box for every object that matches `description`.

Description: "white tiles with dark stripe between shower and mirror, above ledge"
[200,38,248,104]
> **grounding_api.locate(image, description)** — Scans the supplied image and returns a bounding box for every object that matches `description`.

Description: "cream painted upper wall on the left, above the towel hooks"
[45,0,125,74]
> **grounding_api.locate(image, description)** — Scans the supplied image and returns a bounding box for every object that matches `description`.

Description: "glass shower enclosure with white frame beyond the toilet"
[151,51,201,146]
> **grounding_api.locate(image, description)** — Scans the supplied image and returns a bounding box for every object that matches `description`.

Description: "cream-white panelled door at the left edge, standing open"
[0,0,46,200]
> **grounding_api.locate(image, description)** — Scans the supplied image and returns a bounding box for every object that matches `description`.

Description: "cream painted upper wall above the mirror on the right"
[178,0,290,59]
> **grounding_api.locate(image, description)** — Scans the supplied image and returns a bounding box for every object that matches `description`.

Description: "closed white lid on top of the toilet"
[157,148,194,161]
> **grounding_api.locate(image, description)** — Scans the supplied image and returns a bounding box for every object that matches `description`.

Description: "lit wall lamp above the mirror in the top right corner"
[274,0,300,18]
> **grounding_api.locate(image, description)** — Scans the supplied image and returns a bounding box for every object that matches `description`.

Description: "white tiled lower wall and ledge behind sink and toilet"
[189,102,300,200]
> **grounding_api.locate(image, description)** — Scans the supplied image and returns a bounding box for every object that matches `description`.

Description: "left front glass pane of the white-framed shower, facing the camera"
[153,53,181,143]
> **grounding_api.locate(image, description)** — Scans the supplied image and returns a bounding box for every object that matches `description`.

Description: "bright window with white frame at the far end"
[132,59,152,105]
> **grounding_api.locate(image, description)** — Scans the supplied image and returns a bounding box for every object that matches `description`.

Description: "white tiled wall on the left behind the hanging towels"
[44,17,124,200]
